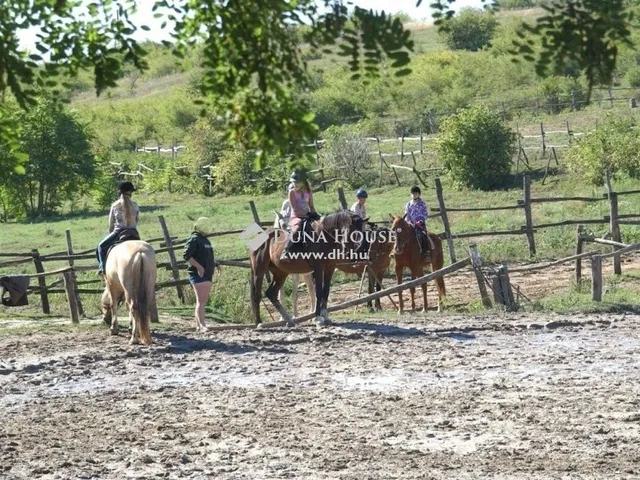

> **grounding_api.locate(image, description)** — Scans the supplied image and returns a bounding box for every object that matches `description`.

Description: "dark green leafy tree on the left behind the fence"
[0,97,95,216]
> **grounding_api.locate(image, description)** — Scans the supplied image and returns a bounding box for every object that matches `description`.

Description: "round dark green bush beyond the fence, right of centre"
[435,107,516,190]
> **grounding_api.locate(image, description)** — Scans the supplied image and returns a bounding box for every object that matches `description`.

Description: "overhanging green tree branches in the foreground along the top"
[0,0,631,163]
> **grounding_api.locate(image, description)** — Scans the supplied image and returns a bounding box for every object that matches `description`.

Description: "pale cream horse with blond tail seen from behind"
[102,240,156,345]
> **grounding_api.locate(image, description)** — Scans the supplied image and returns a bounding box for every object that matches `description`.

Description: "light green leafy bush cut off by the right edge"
[566,115,640,186]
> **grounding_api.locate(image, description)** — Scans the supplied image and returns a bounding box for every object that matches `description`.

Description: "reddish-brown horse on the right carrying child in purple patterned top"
[389,214,446,313]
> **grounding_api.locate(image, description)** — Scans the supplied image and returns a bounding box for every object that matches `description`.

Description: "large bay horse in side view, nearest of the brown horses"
[249,210,362,326]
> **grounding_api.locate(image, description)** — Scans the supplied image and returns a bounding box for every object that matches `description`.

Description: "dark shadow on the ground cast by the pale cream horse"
[153,332,291,355]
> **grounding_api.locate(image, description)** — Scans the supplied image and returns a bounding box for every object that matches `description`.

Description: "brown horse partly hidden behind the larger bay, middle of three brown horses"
[337,228,394,310]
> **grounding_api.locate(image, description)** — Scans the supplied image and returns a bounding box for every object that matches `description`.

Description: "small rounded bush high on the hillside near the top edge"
[442,8,498,52]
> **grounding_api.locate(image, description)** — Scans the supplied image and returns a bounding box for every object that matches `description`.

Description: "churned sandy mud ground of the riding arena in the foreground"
[0,314,640,479]
